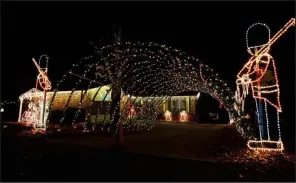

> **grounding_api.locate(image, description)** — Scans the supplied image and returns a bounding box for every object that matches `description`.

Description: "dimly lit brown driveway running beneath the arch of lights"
[48,123,246,160]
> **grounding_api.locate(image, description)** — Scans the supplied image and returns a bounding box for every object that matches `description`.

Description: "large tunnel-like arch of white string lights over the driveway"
[47,41,247,138]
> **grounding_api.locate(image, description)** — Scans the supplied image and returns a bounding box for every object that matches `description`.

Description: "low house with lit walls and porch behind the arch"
[18,86,197,124]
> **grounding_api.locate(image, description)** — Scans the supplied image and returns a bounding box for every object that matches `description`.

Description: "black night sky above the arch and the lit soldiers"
[1,1,295,119]
